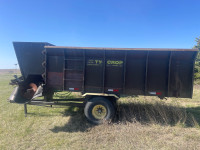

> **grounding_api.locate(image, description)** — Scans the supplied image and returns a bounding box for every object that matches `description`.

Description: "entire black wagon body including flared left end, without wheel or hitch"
[9,42,198,124]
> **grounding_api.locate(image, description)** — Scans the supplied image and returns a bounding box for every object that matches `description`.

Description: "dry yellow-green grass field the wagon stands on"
[0,74,200,150]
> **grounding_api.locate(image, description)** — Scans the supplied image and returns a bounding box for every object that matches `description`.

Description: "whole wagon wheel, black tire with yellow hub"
[84,97,115,124]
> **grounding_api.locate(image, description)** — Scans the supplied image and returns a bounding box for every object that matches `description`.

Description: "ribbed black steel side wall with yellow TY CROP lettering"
[46,48,197,98]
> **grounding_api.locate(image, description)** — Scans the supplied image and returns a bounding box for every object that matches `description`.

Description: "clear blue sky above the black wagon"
[0,0,200,69]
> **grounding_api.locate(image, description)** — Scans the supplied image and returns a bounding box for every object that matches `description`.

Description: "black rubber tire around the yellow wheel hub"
[84,97,115,124]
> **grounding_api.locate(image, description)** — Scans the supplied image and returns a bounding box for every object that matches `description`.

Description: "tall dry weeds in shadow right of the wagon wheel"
[114,98,199,127]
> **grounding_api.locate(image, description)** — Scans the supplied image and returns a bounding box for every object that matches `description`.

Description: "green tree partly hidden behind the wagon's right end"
[194,37,200,80]
